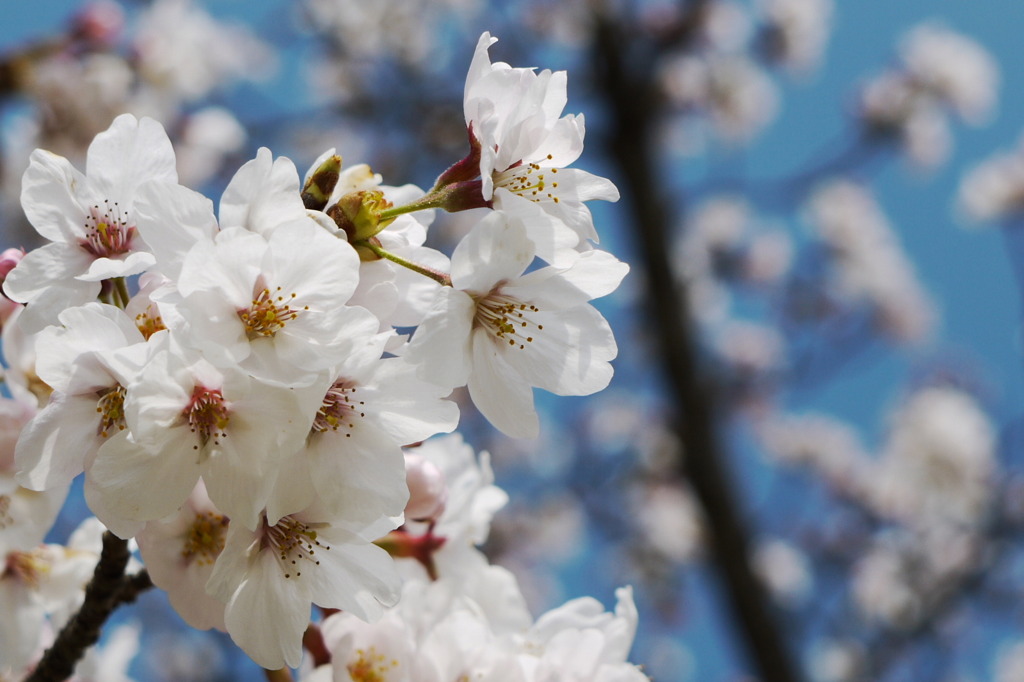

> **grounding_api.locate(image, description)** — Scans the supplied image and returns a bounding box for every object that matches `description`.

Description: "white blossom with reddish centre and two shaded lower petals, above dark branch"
[85,341,310,537]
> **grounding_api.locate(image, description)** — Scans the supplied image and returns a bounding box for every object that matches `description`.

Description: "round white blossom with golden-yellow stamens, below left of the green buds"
[178,218,369,385]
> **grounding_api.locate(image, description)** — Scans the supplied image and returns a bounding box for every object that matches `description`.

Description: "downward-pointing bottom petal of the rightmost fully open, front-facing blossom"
[467,329,541,438]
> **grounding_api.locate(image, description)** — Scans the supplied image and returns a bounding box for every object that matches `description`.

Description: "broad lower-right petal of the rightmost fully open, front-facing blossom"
[505,305,618,395]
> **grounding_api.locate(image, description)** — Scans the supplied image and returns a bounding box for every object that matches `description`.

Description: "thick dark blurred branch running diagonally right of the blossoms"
[593,9,801,682]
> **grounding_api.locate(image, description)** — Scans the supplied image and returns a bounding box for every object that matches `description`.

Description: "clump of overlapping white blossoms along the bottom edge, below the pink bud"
[323,563,647,682]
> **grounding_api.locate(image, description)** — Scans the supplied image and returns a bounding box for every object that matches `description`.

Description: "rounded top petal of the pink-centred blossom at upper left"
[85,114,178,199]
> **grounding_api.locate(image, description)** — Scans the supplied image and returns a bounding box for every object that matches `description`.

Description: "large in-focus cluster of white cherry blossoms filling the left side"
[0,34,644,680]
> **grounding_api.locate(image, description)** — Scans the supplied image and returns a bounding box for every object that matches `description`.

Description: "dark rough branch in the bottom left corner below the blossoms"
[26,531,140,682]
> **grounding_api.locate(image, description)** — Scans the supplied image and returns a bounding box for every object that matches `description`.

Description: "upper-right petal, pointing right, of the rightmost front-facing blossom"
[502,251,630,310]
